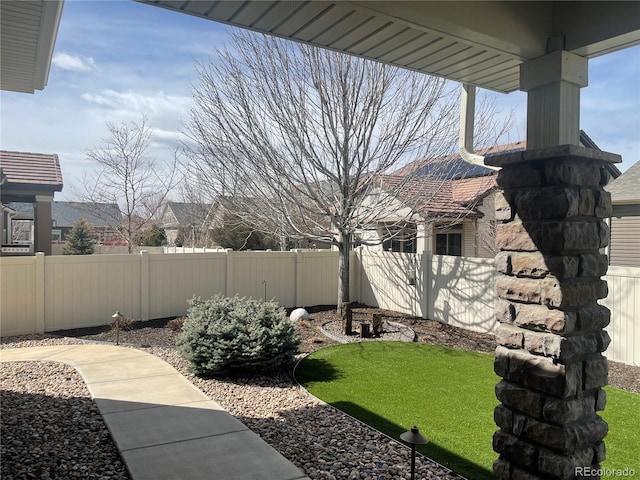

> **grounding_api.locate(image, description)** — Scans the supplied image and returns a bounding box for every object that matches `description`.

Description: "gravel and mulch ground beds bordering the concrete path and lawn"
[0,308,640,480]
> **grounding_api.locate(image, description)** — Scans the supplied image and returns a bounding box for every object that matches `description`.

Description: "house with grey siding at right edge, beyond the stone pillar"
[605,161,640,267]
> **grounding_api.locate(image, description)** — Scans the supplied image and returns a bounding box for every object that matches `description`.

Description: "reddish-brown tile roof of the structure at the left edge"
[0,150,62,191]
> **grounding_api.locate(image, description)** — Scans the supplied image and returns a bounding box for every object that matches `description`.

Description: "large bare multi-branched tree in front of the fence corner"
[185,32,510,308]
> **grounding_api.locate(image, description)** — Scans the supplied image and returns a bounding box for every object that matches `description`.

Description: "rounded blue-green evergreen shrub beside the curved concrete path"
[176,295,299,377]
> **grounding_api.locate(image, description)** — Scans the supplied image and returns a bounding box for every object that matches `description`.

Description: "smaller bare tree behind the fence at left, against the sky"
[77,116,178,253]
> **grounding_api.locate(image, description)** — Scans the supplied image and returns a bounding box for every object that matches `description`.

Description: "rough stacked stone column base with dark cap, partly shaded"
[484,145,619,480]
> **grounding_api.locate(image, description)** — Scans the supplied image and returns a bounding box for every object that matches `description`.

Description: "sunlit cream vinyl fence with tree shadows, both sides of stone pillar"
[352,251,640,365]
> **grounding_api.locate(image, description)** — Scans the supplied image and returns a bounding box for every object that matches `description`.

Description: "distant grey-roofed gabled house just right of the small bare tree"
[159,202,213,247]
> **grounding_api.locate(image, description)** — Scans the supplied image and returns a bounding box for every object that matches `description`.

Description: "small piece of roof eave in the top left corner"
[0,0,63,93]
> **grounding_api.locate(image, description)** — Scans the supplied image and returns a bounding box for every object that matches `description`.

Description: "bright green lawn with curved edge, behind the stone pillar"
[296,342,640,480]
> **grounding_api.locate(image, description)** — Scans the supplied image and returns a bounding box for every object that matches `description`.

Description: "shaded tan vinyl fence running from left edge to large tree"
[0,251,338,336]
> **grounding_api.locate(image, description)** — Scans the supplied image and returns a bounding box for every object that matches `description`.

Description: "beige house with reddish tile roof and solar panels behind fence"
[359,131,620,258]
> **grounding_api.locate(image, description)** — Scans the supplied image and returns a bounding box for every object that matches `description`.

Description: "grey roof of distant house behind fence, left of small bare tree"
[9,202,122,227]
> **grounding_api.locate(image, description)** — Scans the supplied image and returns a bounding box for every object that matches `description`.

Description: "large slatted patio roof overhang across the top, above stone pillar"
[141,0,640,93]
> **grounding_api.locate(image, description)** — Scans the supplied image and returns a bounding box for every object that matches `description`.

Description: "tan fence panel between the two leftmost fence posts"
[44,255,141,332]
